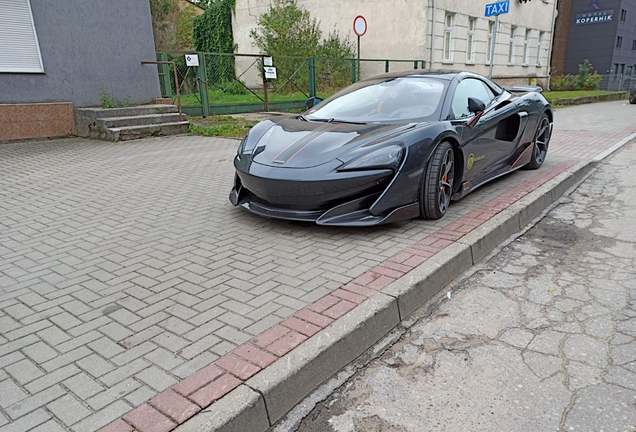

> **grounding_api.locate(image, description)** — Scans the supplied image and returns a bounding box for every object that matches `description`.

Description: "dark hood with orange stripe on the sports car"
[252,118,417,168]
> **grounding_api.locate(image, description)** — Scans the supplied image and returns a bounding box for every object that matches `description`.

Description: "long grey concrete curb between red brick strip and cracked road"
[176,143,636,432]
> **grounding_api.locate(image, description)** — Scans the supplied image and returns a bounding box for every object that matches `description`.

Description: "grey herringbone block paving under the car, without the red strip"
[0,102,636,432]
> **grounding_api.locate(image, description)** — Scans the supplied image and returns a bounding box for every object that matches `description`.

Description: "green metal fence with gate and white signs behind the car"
[157,51,425,116]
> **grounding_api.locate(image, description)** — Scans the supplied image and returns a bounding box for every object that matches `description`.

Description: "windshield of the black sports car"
[305,77,446,123]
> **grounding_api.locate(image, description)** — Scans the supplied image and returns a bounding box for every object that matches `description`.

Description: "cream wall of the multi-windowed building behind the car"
[233,0,556,83]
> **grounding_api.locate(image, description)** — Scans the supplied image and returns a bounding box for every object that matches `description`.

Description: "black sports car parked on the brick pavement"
[230,70,553,226]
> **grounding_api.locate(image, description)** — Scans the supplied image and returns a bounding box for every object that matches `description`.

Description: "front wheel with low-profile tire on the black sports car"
[420,141,455,219]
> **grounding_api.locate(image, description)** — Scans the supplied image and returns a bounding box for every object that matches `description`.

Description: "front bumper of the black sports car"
[230,159,419,226]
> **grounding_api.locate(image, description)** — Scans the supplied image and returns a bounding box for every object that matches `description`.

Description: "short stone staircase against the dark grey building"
[75,105,189,141]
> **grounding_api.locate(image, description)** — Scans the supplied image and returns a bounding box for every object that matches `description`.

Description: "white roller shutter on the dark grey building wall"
[0,0,44,73]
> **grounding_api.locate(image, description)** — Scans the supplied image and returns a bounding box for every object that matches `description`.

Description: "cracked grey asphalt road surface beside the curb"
[298,142,636,432]
